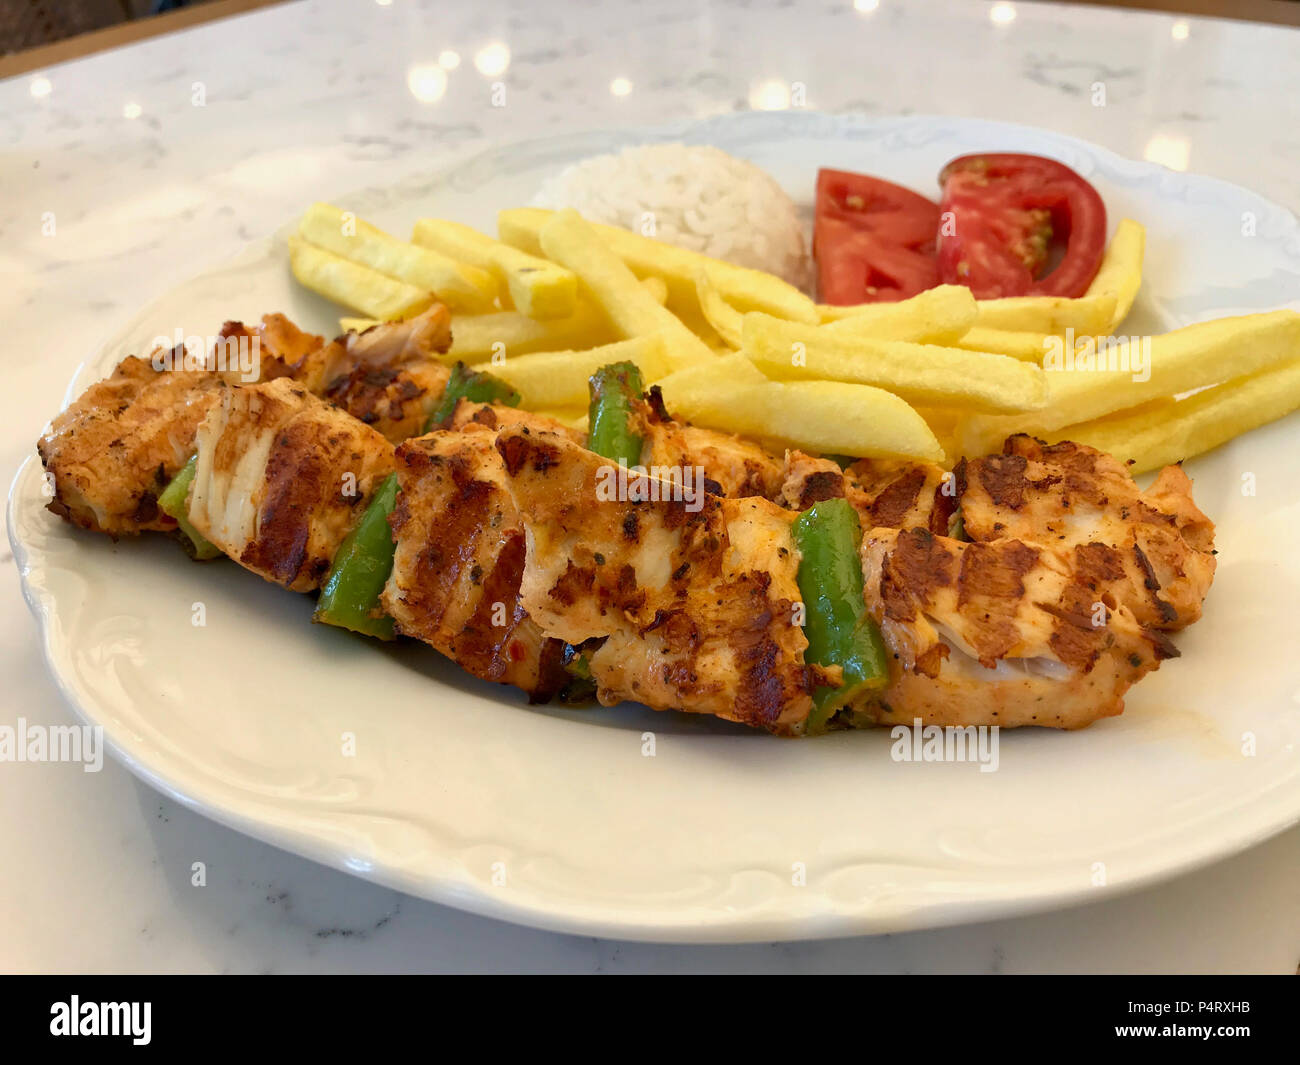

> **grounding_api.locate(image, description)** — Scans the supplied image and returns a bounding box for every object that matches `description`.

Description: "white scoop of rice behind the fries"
[533,144,809,289]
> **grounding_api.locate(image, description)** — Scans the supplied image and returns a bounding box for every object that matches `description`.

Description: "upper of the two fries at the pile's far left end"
[298,203,498,312]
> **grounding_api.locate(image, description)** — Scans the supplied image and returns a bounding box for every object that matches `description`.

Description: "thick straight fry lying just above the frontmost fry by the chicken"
[741,313,1048,412]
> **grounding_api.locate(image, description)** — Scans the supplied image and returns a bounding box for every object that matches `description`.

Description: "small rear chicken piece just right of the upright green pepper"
[631,388,781,499]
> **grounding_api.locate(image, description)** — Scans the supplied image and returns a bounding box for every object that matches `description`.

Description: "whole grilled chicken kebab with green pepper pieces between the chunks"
[38,312,1214,735]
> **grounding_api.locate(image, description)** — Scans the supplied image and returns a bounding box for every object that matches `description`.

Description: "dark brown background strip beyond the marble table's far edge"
[0,0,1300,77]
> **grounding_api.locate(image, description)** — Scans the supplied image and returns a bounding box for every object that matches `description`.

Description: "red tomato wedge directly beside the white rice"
[813,170,939,306]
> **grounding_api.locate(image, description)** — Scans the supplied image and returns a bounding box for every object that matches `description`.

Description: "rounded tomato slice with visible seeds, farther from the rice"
[937,153,1106,299]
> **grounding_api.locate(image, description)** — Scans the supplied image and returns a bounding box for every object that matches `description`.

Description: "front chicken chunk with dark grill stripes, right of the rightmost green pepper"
[853,529,1178,728]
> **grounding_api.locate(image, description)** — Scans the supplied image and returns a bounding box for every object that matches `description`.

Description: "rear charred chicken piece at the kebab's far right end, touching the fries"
[956,436,1214,631]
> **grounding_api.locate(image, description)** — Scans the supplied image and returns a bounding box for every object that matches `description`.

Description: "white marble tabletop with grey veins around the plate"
[0,0,1300,973]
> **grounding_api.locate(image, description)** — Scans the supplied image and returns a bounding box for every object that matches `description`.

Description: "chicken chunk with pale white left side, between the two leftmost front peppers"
[190,378,394,592]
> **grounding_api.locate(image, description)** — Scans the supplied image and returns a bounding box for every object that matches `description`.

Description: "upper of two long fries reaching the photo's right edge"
[962,311,1300,455]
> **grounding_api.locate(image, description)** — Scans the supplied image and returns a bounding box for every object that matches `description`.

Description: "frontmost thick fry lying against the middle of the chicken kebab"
[659,356,944,462]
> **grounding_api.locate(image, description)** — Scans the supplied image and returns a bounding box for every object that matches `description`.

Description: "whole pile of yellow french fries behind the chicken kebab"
[290,204,1300,472]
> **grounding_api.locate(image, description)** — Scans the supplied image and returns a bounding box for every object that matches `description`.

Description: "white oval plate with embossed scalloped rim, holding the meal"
[9,113,1300,940]
